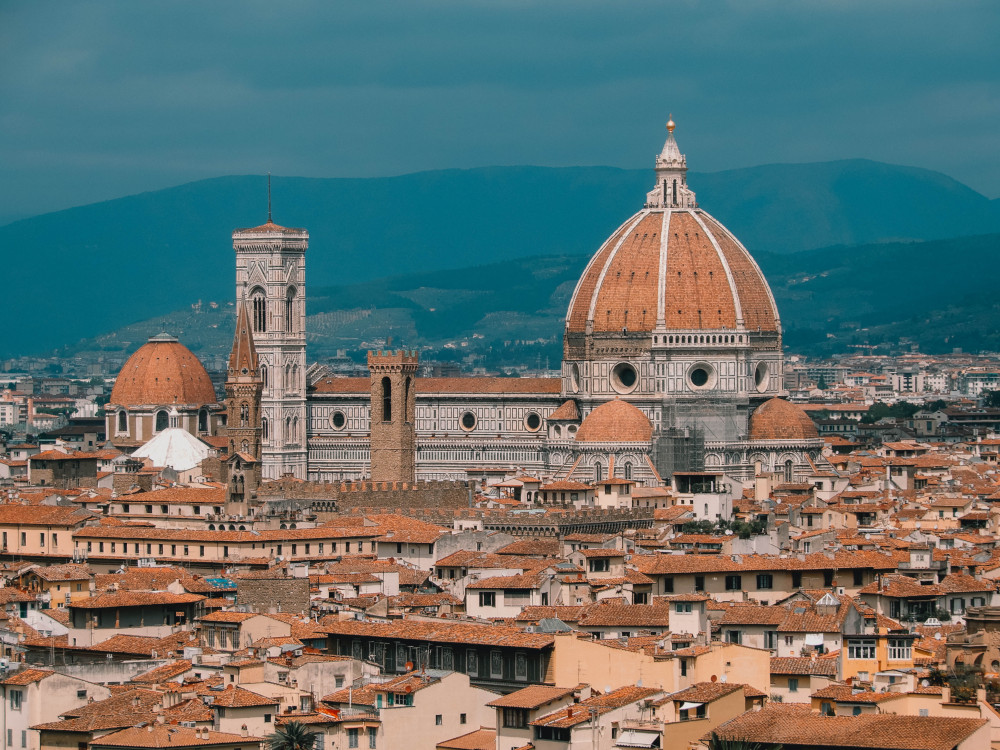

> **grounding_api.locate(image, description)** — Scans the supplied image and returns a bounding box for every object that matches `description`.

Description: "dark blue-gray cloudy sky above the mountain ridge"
[0,0,1000,221]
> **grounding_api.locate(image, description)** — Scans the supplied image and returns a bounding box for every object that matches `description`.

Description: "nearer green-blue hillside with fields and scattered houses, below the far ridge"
[62,234,1000,366]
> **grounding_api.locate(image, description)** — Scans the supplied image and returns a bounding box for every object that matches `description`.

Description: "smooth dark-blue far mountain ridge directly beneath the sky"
[0,160,1000,356]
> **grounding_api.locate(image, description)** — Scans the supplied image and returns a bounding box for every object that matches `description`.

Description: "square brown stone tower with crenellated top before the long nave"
[368,350,418,482]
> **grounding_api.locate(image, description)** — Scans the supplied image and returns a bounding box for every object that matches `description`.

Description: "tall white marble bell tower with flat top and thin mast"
[233,203,309,479]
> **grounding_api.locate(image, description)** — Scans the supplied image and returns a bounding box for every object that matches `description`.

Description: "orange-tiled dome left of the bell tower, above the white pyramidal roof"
[110,333,218,406]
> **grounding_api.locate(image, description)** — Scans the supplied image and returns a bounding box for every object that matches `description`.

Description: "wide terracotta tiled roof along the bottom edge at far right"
[715,704,987,750]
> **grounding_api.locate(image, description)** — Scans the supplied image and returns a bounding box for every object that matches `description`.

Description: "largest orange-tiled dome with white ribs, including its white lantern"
[566,122,780,335]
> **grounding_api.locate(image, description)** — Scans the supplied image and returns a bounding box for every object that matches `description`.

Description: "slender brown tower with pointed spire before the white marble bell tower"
[225,300,263,503]
